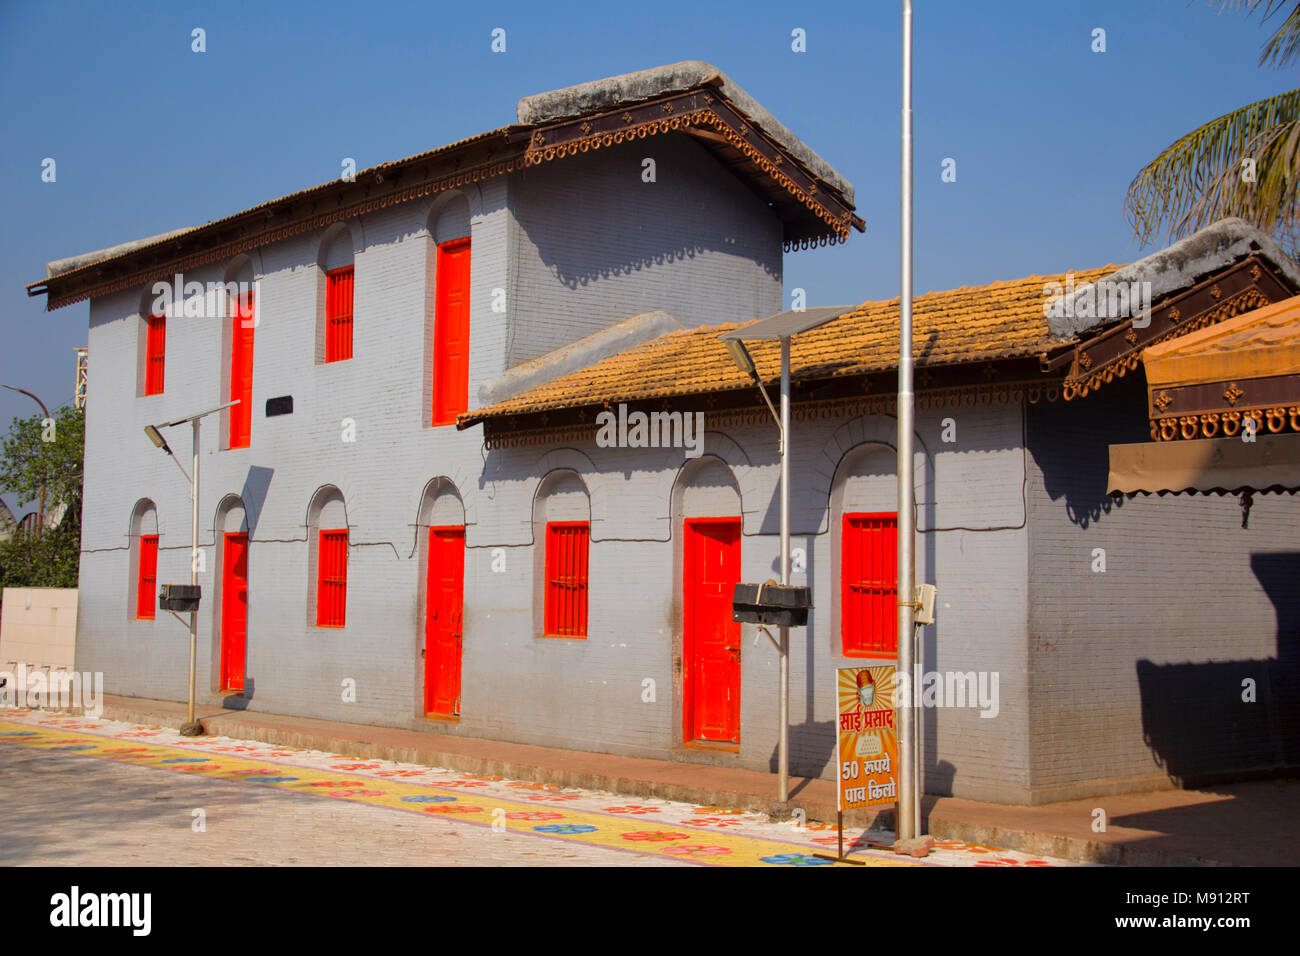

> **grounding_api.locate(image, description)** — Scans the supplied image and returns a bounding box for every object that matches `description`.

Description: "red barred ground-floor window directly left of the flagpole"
[840,514,898,657]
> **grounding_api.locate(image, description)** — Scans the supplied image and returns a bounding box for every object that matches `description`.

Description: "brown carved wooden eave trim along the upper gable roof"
[517,87,866,251]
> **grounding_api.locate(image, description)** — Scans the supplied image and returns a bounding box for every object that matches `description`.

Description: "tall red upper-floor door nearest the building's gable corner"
[433,238,469,425]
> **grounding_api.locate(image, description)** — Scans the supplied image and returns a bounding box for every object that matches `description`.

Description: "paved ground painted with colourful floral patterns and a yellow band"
[0,710,1073,869]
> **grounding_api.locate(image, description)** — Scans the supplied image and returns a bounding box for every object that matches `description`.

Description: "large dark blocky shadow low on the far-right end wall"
[1138,551,1300,787]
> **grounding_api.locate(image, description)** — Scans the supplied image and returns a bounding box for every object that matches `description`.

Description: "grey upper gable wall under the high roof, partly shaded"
[507,135,781,367]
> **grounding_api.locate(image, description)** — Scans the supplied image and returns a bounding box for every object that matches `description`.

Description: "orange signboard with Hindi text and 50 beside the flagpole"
[836,665,898,813]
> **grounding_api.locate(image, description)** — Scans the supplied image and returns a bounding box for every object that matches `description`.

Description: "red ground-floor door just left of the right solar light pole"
[683,518,740,744]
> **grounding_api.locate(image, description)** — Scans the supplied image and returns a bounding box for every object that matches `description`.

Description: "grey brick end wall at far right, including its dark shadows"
[1028,375,1300,801]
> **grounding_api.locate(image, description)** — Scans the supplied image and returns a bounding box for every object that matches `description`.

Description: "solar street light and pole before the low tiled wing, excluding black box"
[718,306,853,804]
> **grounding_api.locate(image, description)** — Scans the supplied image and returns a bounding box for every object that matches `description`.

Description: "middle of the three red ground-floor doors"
[424,527,465,717]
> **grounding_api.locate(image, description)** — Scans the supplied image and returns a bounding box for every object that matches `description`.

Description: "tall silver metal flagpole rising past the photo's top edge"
[896,0,920,842]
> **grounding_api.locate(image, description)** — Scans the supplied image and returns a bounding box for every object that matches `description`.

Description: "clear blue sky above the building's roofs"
[0,0,1296,515]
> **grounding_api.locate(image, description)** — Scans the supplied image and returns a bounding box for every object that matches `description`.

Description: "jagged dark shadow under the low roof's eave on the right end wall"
[1028,375,1151,528]
